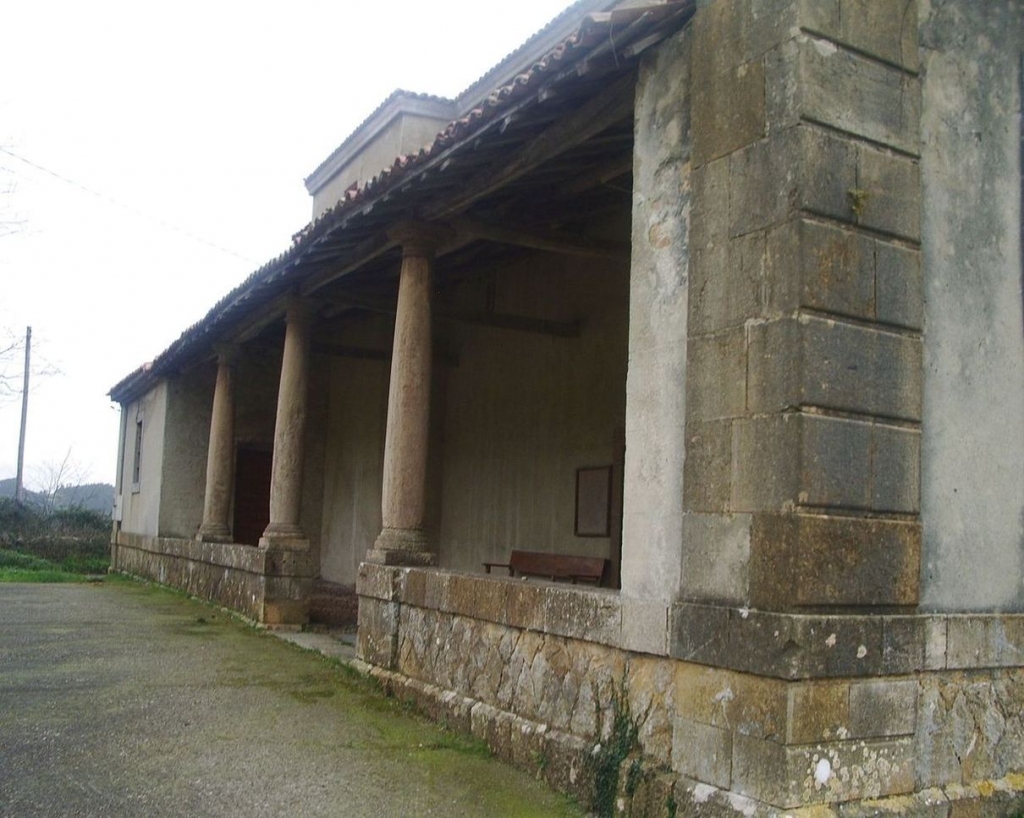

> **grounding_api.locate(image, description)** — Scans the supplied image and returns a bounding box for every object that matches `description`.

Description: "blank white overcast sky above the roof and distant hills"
[0,0,568,487]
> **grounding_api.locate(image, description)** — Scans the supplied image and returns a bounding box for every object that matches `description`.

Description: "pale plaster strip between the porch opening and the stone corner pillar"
[623,25,691,606]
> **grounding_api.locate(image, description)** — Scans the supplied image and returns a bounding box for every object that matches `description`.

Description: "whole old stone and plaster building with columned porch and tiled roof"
[112,0,1024,816]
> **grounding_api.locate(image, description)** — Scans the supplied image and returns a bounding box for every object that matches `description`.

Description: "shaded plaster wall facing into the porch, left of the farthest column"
[159,363,216,539]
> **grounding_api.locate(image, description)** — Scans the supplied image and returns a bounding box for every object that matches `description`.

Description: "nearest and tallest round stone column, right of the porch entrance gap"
[367,224,441,565]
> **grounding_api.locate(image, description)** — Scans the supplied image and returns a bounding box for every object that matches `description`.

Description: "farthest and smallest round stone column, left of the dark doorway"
[196,345,238,543]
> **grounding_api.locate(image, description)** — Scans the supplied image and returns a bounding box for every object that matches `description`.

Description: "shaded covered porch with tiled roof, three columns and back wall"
[112,4,690,625]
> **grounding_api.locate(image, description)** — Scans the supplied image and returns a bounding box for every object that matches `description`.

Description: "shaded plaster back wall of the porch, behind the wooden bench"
[321,254,629,584]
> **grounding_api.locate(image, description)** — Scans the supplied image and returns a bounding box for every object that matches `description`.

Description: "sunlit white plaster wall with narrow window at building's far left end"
[121,381,167,536]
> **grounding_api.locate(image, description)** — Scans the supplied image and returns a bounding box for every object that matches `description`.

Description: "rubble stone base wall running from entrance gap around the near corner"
[357,565,1024,815]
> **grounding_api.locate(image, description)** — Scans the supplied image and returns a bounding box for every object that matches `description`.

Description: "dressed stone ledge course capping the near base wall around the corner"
[356,563,1024,680]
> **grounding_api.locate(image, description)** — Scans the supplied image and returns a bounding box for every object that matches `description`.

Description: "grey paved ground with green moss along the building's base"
[0,582,582,818]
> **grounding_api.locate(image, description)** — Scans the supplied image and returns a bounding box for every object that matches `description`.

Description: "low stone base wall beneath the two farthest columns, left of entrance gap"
[111,531,312,625]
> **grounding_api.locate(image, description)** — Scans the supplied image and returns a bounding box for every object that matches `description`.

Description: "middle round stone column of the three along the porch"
[259,299,309,550]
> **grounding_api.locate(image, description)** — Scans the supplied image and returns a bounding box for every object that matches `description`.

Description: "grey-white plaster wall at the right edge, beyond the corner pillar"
[920,0,1024,610]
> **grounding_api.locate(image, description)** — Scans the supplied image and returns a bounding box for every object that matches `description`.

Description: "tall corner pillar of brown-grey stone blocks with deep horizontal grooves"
[680,0,923,613]
